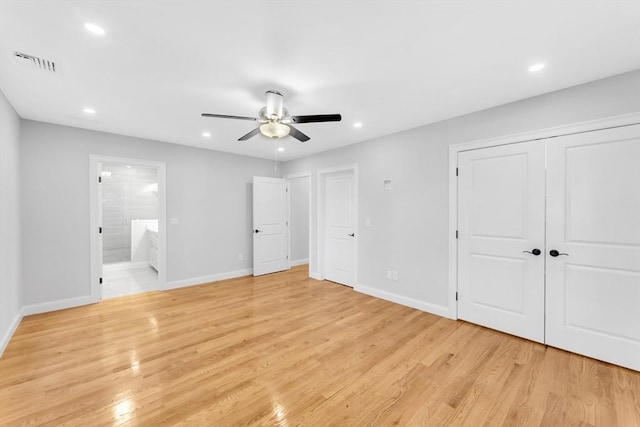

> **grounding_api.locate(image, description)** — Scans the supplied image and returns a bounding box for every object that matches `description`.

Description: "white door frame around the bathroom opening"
[89,154,167,303]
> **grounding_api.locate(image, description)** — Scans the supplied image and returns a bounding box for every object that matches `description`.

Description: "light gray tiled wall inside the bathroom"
[102,163,158,264]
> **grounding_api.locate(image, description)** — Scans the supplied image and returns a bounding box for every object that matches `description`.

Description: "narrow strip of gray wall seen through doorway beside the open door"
[289,176,309,265]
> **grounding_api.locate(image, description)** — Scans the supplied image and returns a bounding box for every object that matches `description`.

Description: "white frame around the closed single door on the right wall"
[316,163,360,289]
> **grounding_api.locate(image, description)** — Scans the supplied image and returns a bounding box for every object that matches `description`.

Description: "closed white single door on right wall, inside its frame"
[324,171,356,287]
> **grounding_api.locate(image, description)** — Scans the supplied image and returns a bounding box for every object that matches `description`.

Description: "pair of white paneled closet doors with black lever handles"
[458,125,640,370]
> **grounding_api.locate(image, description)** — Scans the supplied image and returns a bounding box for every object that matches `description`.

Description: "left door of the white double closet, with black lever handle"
[458,141,545,342]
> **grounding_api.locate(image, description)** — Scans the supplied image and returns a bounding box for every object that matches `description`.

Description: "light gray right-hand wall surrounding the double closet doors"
[283,71,640,315]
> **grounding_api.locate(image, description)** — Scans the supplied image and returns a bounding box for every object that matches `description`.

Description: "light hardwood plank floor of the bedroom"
[0,267,640,427]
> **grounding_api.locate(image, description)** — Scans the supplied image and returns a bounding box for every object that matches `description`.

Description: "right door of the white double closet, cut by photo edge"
[545,125,640,370]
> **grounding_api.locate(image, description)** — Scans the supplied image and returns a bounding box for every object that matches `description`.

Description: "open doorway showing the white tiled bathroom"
[91,156,166,302]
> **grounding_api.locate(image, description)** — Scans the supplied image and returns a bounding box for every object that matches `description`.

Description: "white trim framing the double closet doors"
[448,112,640,319]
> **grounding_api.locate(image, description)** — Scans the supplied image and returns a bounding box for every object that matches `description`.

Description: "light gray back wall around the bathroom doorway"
[20,120,279,311]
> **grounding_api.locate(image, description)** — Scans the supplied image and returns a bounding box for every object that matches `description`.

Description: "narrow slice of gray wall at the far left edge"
[0,92,22,355]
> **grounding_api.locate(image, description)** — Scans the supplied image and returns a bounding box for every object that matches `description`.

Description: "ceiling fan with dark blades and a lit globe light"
[202,90,342,142]
